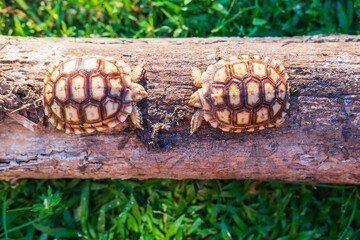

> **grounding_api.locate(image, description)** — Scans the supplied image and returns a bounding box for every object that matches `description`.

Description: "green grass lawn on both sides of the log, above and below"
[0,0,360,240]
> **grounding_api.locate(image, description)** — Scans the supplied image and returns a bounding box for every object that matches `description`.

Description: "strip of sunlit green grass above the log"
[0,0,360,38]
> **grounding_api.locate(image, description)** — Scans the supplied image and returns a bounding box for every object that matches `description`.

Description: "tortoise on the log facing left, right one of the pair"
[189,55,290,134]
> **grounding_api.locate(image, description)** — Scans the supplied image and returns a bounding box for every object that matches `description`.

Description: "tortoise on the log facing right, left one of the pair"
[43,57,148,134]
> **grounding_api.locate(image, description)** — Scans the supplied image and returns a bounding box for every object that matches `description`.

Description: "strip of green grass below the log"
[0,179,360,240]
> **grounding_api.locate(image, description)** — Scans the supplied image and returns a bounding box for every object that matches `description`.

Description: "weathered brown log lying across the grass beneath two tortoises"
[0,35,360,184]
